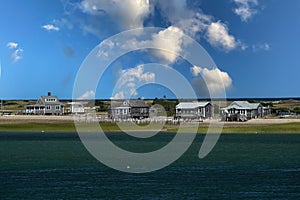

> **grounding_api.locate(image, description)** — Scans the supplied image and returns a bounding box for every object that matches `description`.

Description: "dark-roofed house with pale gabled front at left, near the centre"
[108,99,150,119]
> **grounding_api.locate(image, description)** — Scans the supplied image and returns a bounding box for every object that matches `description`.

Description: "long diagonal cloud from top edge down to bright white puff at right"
[157,0,240,51]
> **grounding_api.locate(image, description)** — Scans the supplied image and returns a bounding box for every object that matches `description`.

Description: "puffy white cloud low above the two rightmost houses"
[191,66,232,97]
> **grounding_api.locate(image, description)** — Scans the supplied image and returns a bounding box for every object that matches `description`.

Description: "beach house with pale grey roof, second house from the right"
[175,102,214,120]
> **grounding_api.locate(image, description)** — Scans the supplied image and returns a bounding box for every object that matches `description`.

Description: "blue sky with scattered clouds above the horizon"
[0,0,300,99]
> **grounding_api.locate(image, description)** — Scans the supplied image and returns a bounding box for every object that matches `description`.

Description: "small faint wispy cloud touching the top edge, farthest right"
[233,0,258,22]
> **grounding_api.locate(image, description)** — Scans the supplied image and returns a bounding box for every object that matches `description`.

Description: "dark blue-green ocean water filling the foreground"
[0,132,300,199]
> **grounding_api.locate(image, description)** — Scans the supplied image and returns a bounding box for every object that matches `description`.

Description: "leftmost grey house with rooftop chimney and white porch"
[25,92,64,115]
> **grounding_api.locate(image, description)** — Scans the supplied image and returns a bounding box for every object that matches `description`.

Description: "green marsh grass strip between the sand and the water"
[0,123,300,133]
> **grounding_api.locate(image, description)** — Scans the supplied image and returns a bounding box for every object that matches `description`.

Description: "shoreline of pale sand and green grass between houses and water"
[0,115,300,134]
